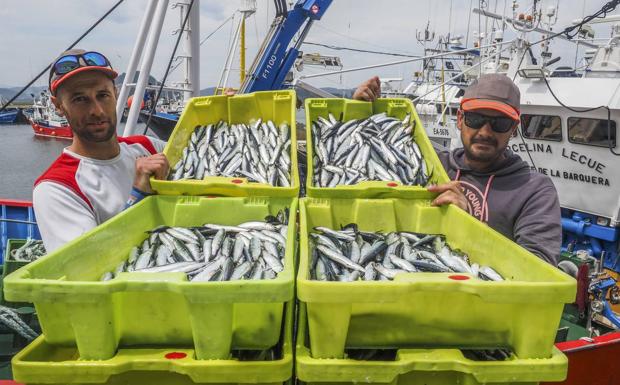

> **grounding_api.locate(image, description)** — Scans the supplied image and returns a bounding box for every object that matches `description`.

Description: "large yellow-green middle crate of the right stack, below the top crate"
[297,198,576,359]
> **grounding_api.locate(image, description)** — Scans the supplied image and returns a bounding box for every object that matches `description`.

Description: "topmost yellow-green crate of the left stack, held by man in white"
[151,90,299,197]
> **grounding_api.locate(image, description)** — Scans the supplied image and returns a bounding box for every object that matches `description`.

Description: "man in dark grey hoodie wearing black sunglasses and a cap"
[353,74,562,265]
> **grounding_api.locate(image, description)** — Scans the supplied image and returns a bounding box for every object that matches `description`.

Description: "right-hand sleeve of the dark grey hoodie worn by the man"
[514,181,562,266]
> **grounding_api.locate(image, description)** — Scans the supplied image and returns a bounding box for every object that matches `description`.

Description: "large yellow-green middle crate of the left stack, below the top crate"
[4,196,297,359]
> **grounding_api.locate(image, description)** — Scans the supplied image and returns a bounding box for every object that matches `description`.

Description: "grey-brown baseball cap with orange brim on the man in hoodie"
[461,74,521,121]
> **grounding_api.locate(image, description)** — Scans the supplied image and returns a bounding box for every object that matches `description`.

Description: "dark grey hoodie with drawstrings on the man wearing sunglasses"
[438,148,562,265]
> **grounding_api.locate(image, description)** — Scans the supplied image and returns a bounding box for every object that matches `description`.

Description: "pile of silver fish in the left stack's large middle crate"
[101,209,288,282]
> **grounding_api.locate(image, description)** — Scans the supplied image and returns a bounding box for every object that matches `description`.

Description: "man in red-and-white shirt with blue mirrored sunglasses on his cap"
[32,49,168,252]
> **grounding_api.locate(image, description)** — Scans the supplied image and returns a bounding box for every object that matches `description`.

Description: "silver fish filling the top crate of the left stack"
[168,119,291,187]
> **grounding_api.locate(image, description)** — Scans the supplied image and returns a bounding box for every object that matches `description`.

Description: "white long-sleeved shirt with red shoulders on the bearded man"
[32,136,166,253]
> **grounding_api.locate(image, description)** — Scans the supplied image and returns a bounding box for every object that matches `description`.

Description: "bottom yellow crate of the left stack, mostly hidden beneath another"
[12,302,294,385]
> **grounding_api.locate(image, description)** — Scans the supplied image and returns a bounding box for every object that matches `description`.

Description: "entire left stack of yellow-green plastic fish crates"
[4,91,299,385]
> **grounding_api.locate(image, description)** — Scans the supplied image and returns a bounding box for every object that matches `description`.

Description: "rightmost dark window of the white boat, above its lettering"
[568,118,616,147]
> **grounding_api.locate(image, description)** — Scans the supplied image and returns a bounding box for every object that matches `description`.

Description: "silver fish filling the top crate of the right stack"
[311,112,432,187]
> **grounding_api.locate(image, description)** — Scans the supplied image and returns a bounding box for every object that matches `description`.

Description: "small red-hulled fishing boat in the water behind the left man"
[27,90,73,139]
